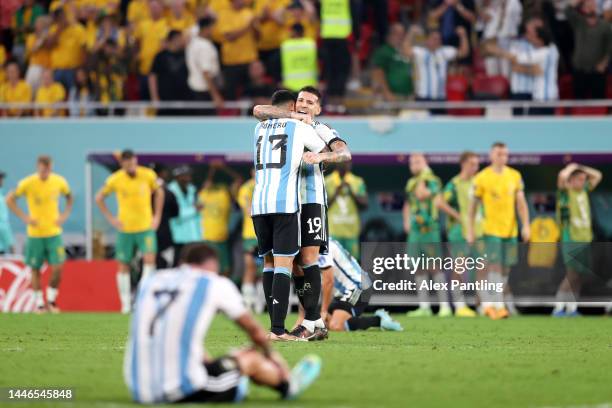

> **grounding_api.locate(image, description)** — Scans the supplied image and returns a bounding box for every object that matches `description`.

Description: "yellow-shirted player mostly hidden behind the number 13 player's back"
[236,169,258,309]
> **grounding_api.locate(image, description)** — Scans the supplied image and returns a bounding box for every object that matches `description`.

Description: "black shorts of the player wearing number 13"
[253,213,301,256]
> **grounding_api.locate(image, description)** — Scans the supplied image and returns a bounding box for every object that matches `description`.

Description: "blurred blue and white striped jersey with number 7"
[123,266,246,403]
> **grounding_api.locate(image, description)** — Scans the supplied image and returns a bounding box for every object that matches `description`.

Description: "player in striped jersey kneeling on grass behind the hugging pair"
[319,239,403,331]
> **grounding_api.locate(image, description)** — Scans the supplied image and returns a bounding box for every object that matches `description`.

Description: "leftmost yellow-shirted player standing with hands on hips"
[6,156,73,312]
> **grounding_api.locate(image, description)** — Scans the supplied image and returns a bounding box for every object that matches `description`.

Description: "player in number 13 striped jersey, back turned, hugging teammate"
[251,90,325,340]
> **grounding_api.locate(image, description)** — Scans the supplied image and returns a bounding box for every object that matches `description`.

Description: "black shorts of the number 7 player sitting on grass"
[179,356,244,402]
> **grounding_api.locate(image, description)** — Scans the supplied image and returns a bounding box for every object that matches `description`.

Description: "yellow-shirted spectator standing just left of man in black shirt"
[134,0,170,100]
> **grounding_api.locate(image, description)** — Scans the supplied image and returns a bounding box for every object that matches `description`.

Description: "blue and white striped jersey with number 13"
[251,119,325,215]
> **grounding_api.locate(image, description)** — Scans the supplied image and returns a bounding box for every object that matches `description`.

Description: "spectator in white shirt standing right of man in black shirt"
[187,17,223,115]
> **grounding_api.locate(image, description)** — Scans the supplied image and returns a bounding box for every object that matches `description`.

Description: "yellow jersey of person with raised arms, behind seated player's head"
[198,186,232,242]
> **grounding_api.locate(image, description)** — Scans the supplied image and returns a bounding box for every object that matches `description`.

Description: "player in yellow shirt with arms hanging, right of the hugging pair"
[466,142,531,319]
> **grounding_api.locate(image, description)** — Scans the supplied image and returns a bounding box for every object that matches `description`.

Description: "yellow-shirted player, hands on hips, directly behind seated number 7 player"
[96,150,164,313]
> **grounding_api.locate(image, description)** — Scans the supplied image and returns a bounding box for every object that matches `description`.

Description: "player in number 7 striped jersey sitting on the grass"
[124,244,321,403]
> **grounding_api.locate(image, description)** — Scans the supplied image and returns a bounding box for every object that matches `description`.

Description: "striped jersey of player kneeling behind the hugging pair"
[319,238,371,305]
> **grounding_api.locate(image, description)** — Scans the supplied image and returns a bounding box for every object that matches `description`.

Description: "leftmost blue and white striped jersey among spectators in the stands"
[412,46,457,99]
